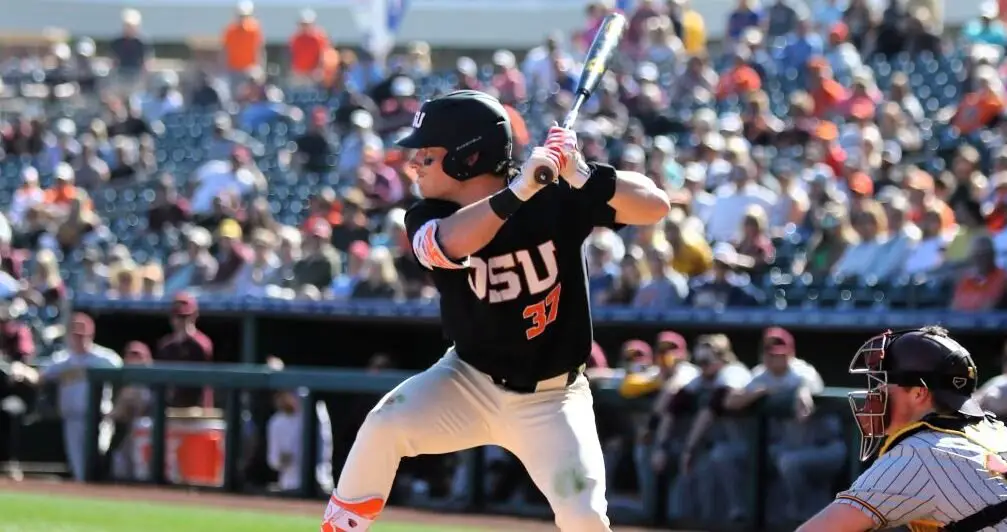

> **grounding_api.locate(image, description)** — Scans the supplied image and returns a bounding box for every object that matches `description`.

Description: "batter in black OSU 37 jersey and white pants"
[321,91,669,532]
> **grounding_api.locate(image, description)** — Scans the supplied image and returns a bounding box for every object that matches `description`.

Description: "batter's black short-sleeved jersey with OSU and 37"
[406,165,615,382]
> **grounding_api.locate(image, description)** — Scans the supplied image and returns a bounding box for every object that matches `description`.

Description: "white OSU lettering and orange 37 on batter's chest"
[468,241,561,340]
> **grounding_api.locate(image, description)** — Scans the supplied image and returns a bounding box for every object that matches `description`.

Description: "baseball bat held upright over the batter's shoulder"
[535,13,626,184]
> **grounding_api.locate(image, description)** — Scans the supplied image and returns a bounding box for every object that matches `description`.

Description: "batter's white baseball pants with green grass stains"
[334,351,611,532]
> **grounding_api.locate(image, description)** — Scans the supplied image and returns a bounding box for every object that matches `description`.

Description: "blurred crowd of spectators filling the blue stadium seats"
[0,0,1007,332]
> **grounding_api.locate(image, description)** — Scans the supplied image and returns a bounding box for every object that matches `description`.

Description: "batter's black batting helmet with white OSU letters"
[398,91,514,180]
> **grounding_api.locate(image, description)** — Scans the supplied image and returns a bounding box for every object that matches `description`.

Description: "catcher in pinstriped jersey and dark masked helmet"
[799,326,1007,532]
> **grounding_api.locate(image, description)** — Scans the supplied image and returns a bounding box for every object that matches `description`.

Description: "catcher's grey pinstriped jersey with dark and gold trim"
[837,421,1007,532]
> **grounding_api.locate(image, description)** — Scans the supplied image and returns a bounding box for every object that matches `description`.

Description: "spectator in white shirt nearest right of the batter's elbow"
[706,152,777,242]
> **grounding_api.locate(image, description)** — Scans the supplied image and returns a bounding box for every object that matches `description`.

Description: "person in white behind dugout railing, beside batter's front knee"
[266,378,333,493]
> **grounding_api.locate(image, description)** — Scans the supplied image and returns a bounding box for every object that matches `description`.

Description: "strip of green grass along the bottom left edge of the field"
[0,492,487,532]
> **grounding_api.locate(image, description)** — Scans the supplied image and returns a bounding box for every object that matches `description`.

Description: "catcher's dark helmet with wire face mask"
[849,326,986,460]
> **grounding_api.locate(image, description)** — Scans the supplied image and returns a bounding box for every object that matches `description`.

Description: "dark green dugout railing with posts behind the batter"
[85,364,858,531]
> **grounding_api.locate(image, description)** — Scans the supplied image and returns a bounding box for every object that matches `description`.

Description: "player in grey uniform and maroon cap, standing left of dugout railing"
[15,312,123,482]
